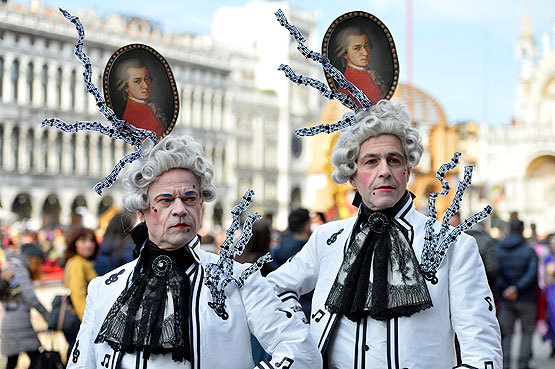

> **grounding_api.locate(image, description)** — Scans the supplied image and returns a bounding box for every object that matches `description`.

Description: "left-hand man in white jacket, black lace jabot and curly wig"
[68,136,322,369]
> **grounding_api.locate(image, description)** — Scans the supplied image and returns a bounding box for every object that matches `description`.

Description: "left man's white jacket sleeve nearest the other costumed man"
[239,272,322,369]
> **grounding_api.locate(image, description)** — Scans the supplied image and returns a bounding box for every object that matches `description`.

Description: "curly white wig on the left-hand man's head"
[123,136,216,212]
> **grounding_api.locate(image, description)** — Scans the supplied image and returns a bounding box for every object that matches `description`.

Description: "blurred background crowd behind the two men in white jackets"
[0,203,555,369]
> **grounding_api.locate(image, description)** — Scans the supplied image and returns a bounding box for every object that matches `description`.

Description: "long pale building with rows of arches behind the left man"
[0,0,319,228]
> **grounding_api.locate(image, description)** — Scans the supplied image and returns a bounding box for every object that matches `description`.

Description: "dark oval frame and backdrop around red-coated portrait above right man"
[322,11,399,100]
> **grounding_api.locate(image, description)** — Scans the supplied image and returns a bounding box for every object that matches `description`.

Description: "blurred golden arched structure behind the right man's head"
[309,83,457,219]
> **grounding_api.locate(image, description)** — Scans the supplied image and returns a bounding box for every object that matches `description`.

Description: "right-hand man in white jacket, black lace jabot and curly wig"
[267,100,502,369]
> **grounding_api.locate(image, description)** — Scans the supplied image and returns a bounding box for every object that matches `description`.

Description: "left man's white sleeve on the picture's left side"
[66,278,101,369]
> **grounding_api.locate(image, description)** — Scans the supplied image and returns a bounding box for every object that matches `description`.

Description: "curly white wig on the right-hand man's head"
[331,100,424,184]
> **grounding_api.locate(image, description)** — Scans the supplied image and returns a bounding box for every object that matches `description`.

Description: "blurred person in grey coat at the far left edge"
[1,243,48,369]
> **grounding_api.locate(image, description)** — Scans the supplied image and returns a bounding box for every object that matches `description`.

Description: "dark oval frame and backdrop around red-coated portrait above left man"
[102,44,179,138]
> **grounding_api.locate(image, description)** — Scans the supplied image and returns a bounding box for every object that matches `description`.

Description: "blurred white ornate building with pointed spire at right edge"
[479,11,555,235]
